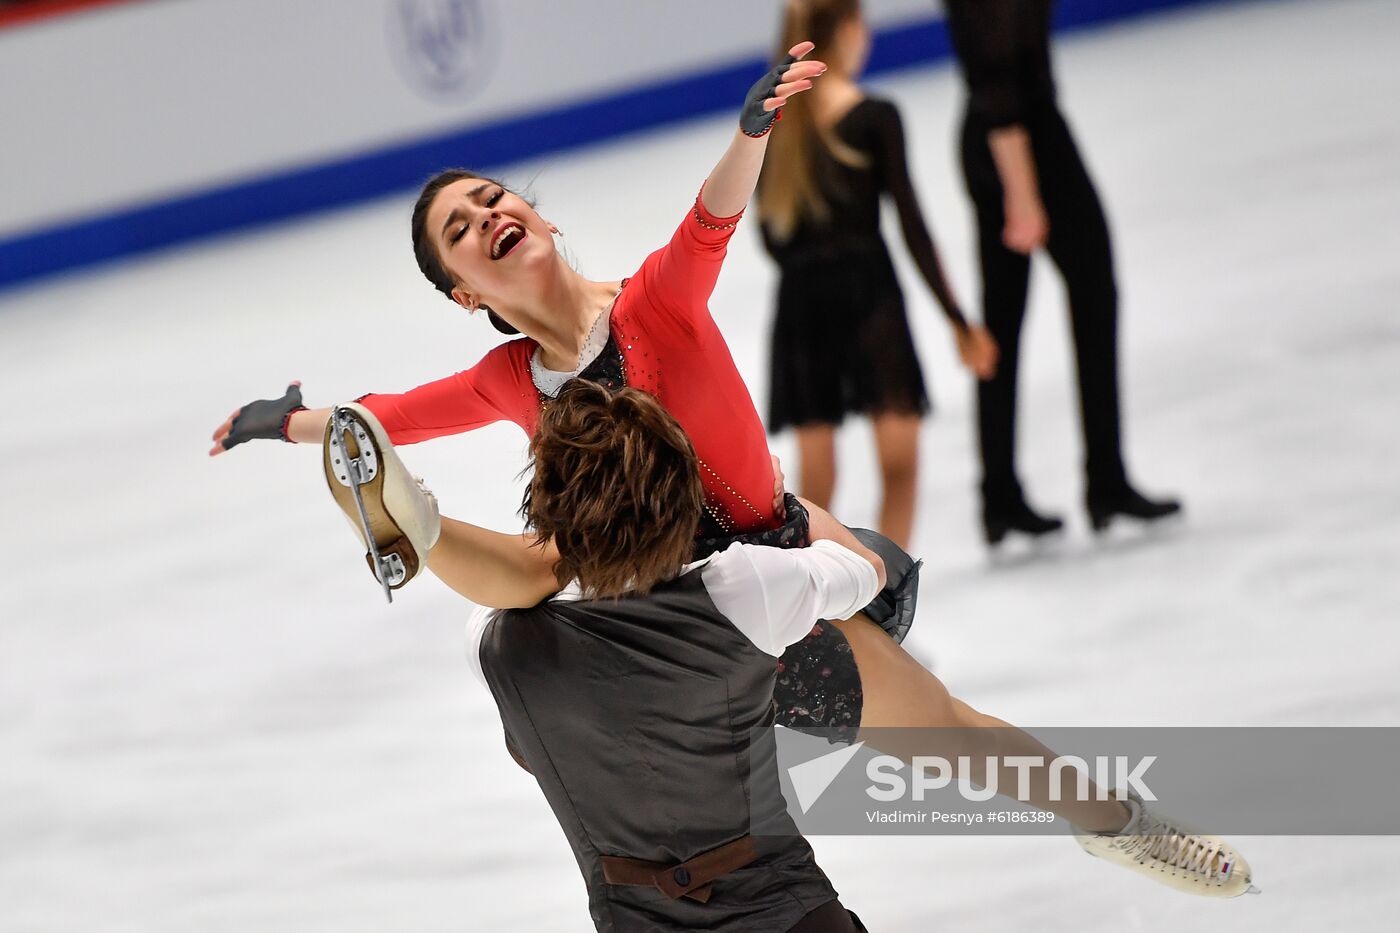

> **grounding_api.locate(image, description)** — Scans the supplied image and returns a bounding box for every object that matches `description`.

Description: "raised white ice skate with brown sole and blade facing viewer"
[322,403,441,602]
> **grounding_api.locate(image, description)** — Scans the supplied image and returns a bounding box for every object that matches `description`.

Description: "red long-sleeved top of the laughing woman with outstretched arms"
[361,191,777,532]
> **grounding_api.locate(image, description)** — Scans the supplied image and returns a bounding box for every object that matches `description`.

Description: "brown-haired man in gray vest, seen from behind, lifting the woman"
[350,380,883,933]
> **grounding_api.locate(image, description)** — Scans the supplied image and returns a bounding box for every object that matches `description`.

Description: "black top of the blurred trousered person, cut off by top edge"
[944,0,1054,127]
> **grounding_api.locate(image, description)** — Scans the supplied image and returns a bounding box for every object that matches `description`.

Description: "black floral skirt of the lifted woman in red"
[696,495,865,741]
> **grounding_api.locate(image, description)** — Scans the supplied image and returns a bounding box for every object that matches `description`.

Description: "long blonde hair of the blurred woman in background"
[759,0,869,241]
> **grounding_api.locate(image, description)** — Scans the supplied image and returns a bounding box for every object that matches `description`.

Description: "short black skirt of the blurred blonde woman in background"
[769,245,930,433]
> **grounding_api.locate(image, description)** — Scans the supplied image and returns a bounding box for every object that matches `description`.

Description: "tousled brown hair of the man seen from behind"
[521,380,703,600]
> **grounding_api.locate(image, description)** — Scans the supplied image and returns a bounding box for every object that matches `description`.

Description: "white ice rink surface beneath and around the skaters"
[0,0,1400,933]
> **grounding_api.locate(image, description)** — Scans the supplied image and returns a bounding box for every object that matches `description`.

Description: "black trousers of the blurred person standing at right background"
[962,106,1127,510]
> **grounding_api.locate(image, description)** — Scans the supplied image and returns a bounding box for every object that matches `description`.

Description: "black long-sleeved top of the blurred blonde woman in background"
[763,98,966,326]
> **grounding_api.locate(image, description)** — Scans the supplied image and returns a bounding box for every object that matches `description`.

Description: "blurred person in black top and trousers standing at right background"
[945,0,1182,545]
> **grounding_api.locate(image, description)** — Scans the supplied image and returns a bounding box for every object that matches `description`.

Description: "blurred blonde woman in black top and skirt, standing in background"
[757,0,997,548]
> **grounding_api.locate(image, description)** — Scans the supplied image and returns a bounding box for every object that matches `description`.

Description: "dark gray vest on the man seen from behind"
[482,570,836,933]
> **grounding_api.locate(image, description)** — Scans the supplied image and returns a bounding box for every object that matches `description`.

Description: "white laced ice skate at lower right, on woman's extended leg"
[1075,793,1259,898]
